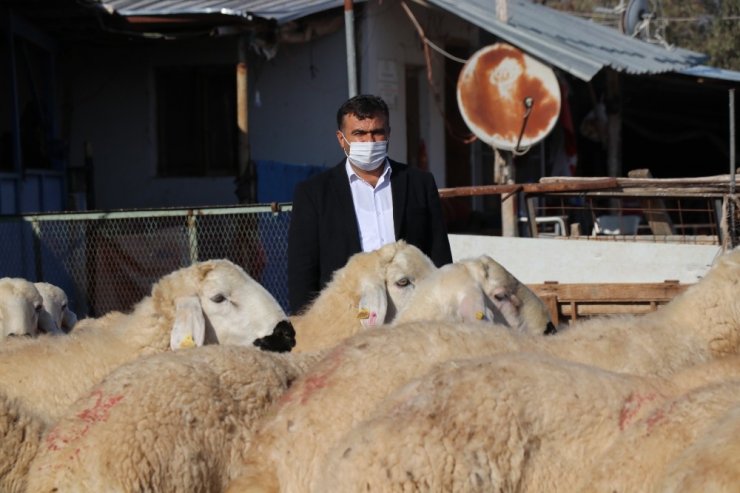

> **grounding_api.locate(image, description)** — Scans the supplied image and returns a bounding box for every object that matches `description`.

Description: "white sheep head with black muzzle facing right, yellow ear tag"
[151,259,295,351]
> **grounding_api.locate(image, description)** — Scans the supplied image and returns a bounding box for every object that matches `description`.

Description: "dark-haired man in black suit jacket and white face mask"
[288,95,452,314]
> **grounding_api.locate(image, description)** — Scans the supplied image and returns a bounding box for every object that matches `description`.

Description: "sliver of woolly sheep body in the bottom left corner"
[0,392,45,493]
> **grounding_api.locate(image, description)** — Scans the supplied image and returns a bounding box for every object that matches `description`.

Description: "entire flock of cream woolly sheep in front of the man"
[0,241,740,493]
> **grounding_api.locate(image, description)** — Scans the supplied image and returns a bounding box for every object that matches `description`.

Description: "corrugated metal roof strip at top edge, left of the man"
[99,0,344,24]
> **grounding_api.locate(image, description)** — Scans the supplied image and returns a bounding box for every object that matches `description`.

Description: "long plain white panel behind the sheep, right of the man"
[450,234,721,284]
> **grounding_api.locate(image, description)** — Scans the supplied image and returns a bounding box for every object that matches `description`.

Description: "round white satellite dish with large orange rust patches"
[457,43,560,152]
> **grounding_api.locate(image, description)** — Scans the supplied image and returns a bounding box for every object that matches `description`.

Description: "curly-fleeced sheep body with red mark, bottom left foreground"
[28,346,320,492]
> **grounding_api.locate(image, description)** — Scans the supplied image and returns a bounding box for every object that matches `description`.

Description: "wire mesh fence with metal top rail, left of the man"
[0,204,292,316]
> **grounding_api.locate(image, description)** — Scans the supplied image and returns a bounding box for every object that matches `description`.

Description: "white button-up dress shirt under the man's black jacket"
[345,159,396,252]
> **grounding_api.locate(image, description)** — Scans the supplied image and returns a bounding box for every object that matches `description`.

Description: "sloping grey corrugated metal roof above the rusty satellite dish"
[428,0,707,81]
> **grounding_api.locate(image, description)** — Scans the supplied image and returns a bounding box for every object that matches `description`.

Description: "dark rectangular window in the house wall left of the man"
[155,66,238,177]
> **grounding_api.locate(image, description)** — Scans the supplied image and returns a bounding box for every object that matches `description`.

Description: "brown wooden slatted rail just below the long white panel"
[528,281,690,325]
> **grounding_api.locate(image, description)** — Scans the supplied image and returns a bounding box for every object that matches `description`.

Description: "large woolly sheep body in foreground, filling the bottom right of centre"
[306,353,740,492]
